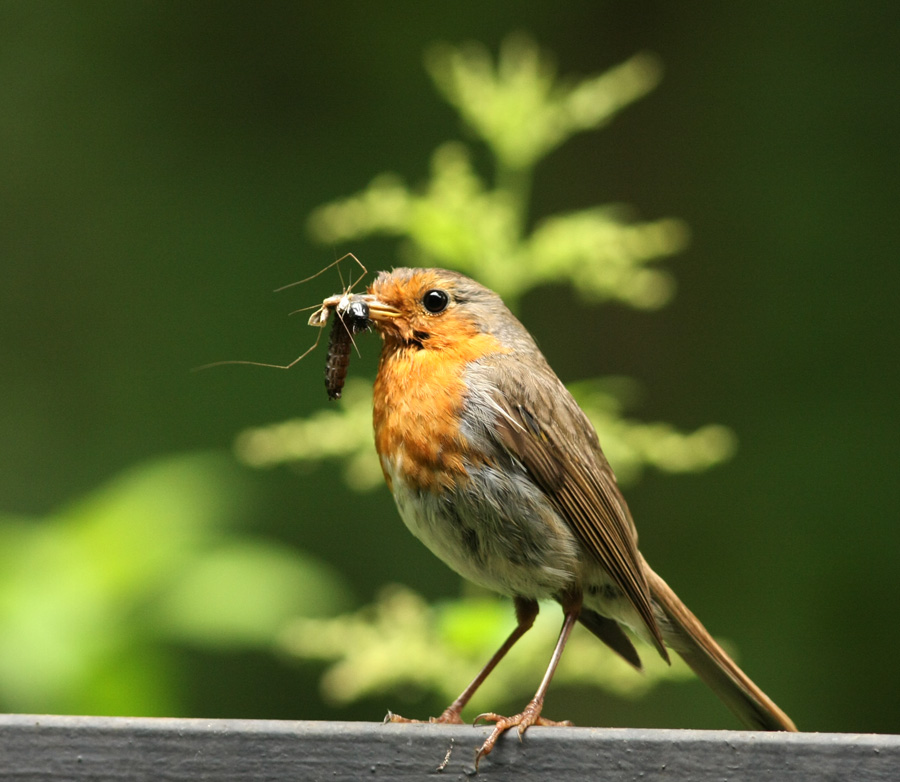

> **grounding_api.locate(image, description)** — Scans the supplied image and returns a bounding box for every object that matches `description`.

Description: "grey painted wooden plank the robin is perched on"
[0,715,900,782]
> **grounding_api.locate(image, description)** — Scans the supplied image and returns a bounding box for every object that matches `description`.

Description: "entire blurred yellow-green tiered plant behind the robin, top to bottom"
[236,37,734,703]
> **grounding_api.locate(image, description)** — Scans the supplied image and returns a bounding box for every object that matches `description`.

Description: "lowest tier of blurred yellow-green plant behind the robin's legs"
[281,587,692,713]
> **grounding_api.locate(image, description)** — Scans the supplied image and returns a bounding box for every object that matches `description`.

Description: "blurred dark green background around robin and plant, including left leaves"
[0,0,900,732]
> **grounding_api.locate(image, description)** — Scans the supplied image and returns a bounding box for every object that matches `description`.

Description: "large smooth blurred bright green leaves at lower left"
[0,455,346,715]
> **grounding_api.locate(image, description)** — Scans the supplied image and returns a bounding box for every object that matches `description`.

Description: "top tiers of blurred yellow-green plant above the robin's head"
[310,36,687,308]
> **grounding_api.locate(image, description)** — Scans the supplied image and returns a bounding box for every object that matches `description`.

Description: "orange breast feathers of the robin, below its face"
[373,334,508,491]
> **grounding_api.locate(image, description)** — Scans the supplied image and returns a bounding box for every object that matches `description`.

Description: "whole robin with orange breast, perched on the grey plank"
[338,268,796,764]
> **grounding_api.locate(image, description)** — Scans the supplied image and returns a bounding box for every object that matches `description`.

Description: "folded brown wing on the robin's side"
[493,372,669,661]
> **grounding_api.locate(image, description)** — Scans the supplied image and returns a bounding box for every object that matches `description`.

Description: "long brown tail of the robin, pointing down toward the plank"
[644,563,797,731]
